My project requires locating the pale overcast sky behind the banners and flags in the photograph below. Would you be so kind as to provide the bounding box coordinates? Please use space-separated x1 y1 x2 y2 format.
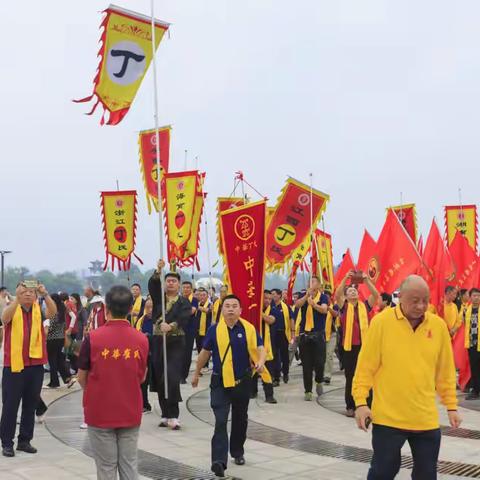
0 0 480 271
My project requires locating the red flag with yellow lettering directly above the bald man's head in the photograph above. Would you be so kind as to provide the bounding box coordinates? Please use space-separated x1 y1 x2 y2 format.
376 210 421 293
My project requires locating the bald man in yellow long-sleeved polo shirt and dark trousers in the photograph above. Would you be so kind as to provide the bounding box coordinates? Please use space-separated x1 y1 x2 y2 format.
352 275 461 480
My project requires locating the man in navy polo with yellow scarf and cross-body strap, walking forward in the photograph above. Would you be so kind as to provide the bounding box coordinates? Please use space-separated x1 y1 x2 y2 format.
192 295 266 477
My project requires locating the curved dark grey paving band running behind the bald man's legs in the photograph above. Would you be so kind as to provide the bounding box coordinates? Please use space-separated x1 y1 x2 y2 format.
187 389 480 478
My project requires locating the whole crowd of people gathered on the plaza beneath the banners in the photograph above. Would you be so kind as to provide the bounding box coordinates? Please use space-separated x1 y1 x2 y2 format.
0 260 480 480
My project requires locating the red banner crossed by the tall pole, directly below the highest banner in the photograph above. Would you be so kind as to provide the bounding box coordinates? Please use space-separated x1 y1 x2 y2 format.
138 126 171 213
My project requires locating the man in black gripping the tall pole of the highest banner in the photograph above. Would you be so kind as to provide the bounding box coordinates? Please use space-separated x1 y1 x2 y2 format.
148 260 192 430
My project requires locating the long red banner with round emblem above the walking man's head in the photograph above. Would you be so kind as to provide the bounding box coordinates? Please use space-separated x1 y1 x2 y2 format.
220 200 267 331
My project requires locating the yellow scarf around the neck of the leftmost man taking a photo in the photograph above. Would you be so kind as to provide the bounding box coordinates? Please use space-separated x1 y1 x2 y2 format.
10 302 43 373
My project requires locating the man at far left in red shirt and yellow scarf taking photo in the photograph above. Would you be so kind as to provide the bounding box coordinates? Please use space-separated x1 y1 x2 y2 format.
0 283 57 457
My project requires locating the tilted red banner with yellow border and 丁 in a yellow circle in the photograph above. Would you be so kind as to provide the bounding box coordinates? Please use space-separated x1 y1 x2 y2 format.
267 178 330 271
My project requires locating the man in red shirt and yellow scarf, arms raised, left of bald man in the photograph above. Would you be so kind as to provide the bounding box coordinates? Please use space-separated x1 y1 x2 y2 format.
335 270 378 418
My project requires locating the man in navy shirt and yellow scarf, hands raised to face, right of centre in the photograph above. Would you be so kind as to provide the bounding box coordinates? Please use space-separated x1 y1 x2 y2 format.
295 276 328 402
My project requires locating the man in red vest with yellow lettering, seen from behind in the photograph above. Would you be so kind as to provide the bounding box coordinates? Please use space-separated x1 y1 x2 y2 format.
78 286 148 480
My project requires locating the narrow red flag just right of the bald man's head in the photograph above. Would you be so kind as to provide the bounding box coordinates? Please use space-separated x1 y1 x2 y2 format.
421 220 454 315
